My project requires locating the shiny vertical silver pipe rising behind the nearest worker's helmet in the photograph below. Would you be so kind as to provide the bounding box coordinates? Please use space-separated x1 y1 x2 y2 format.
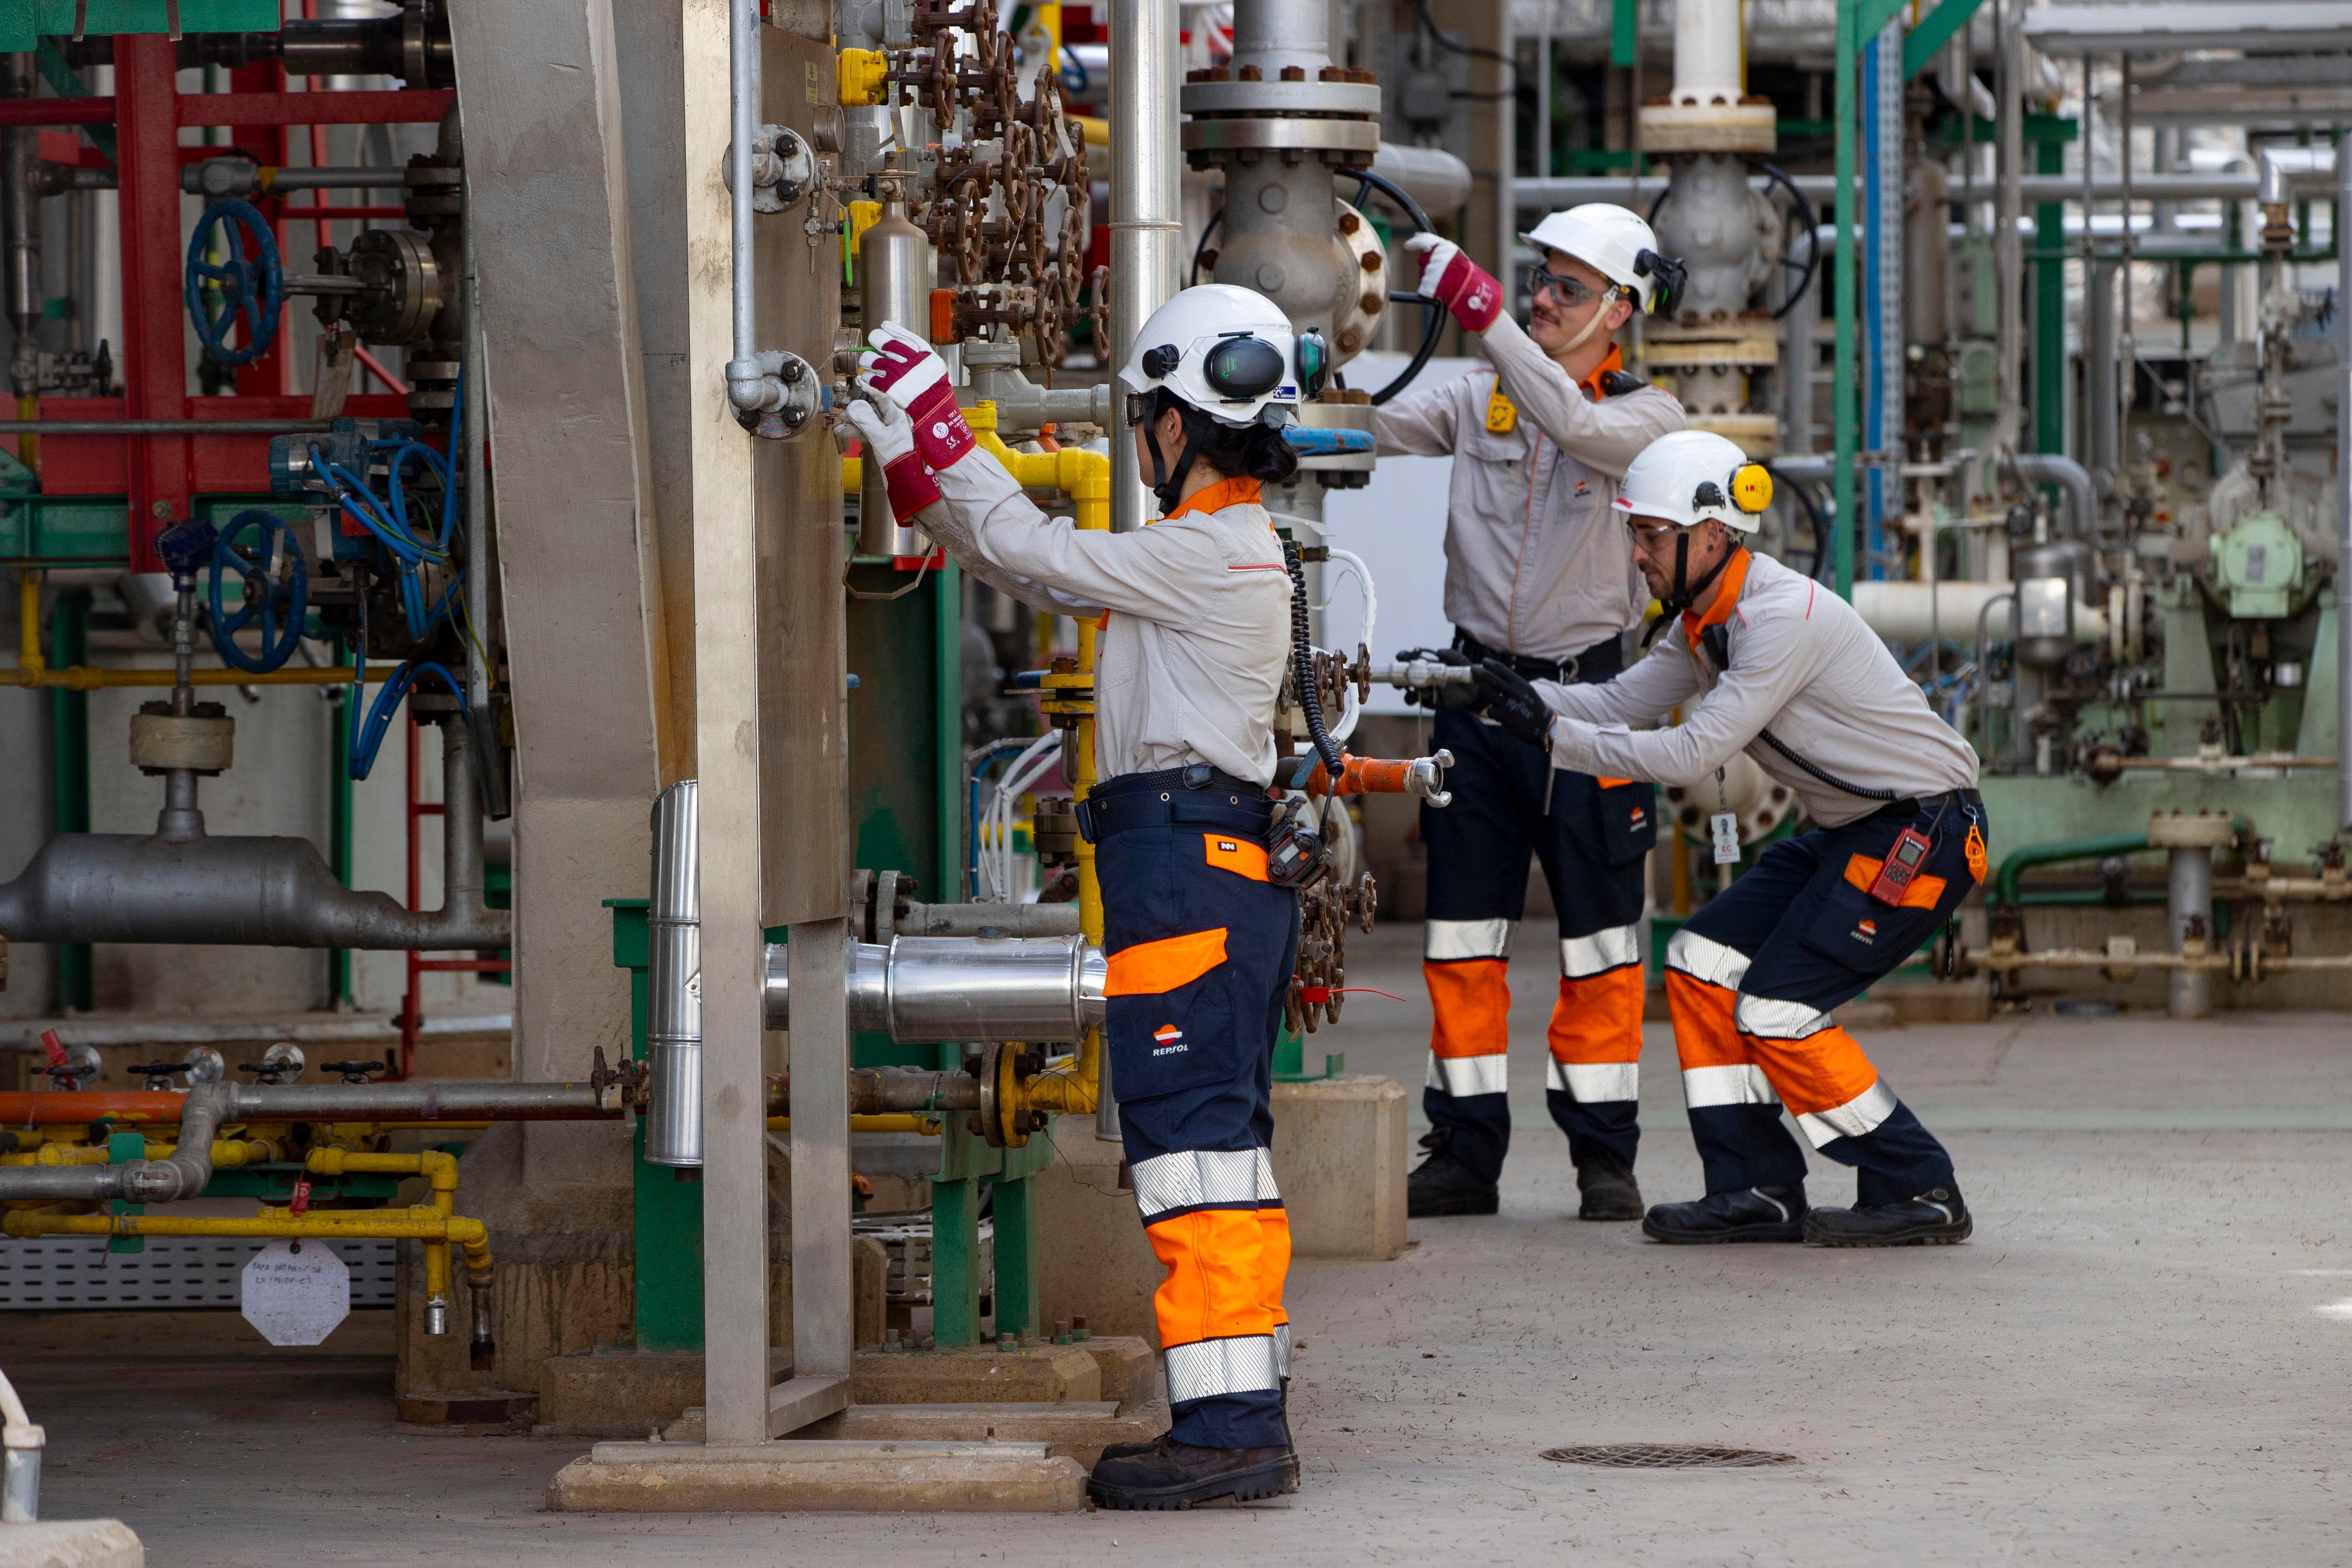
1100 0 1183 534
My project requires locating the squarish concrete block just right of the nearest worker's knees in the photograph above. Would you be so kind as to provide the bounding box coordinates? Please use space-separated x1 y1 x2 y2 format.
1279 1074 1406 1260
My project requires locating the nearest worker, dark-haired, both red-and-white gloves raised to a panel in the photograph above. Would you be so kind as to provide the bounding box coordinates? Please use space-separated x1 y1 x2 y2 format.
847 284 1312 1507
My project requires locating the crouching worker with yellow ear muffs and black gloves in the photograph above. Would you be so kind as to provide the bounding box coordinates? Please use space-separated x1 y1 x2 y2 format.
1479 430 1985 1246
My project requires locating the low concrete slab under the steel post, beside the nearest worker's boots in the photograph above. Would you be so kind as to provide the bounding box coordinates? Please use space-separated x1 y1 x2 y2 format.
548 1438 1087 1514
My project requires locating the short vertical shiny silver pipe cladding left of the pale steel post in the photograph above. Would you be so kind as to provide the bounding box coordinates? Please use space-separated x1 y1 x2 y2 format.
644 778 703 1166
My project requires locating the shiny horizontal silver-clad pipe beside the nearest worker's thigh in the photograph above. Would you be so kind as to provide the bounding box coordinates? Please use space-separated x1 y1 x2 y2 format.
767 936 1110 1044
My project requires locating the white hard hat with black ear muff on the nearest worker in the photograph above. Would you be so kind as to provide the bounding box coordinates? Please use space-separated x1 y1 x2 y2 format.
1120 282 1329 425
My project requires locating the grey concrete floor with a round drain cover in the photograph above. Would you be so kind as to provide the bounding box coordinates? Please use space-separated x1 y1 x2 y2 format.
18 926 2352 1568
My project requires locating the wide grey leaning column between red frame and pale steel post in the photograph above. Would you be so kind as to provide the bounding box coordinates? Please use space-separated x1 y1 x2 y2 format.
451 0 666 1187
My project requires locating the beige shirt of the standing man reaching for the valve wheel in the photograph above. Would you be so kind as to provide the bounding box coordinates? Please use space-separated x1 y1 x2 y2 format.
1378 315 1684 658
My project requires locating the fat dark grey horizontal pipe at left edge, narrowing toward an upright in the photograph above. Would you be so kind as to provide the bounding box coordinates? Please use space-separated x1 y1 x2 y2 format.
0 722 513 952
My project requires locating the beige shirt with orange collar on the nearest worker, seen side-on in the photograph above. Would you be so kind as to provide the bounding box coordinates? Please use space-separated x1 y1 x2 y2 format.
917 449 1291 785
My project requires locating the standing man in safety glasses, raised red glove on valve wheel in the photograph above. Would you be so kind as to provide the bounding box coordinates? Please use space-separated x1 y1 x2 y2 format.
1378 202 1682 1220
